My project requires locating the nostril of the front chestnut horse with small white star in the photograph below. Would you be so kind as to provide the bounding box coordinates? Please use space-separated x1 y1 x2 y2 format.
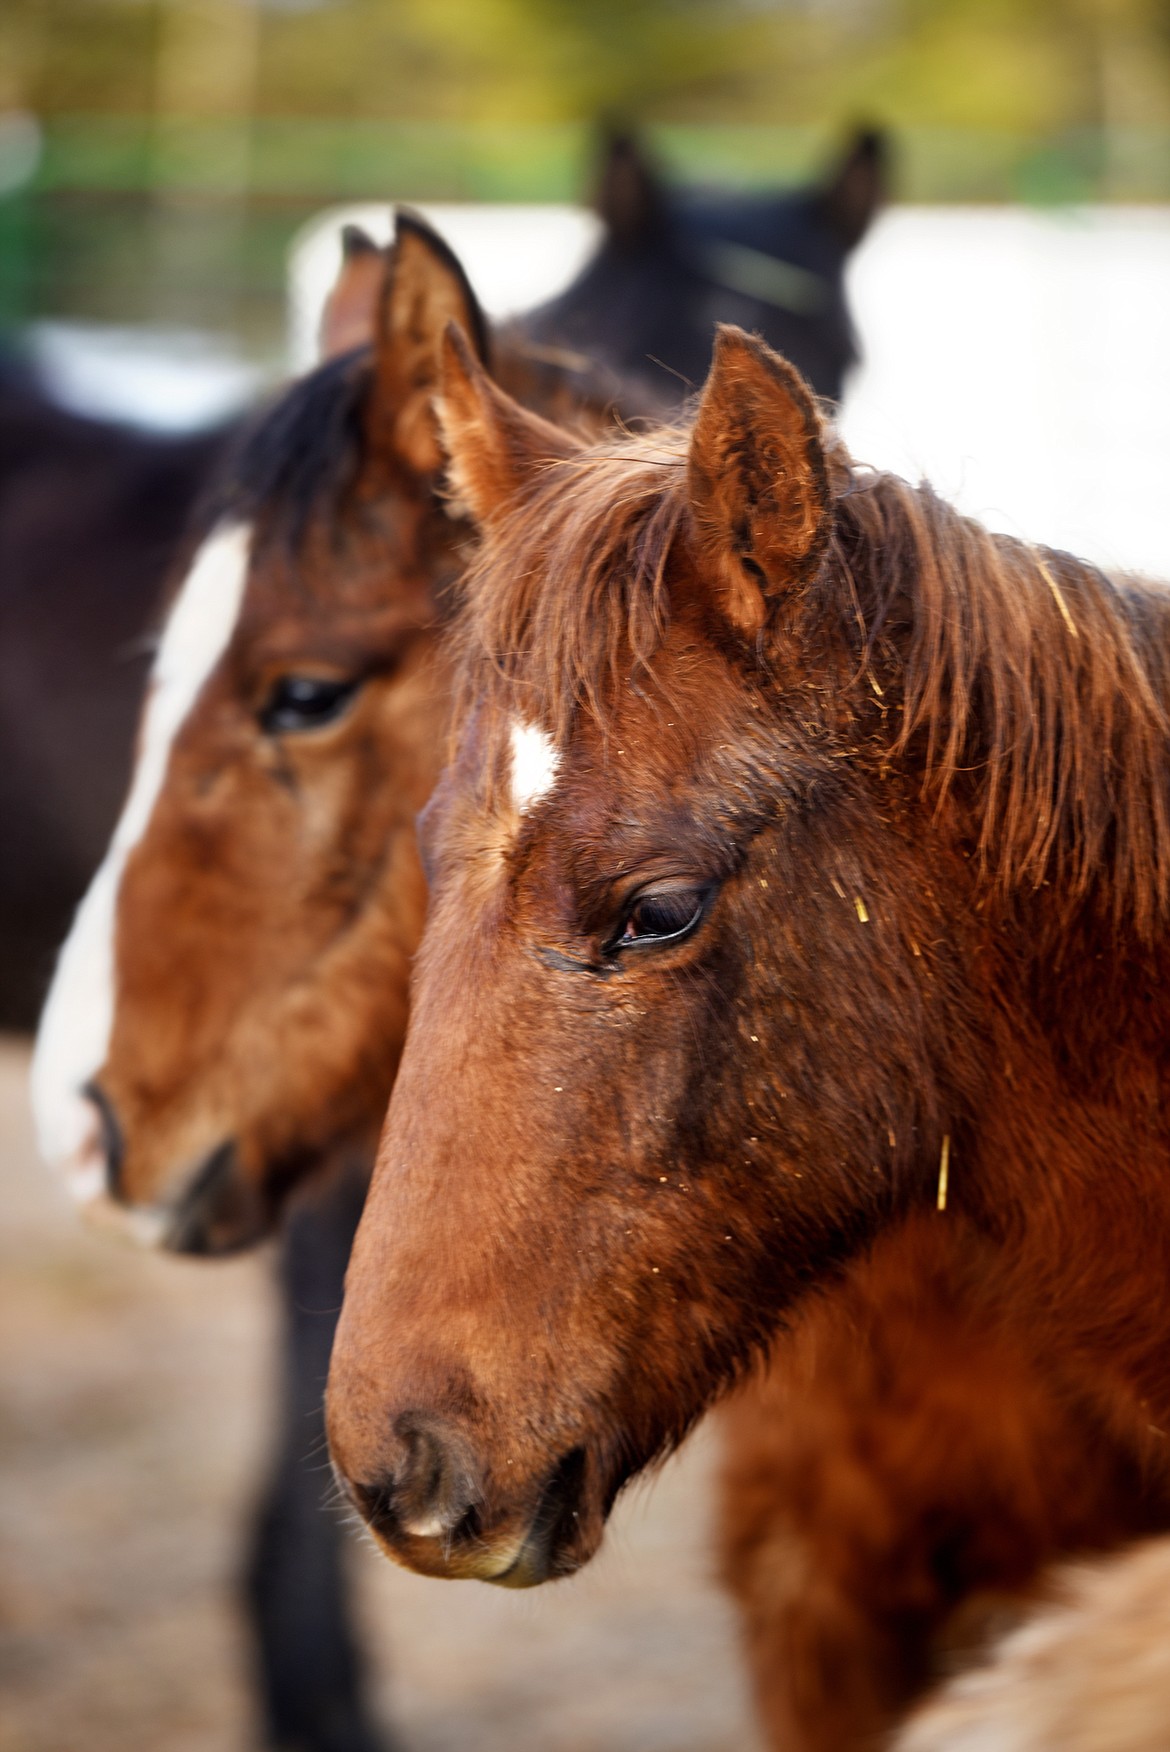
350 1412 482 1538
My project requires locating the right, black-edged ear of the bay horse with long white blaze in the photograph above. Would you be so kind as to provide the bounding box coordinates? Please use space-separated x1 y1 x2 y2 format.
368 207 489 475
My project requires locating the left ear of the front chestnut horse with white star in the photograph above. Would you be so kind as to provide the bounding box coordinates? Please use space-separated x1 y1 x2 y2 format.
436 322 581 524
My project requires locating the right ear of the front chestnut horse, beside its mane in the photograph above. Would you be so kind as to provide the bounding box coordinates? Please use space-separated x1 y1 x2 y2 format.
687 326 832 638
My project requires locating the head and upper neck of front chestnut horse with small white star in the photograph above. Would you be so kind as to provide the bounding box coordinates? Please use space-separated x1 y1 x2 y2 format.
328 329 1170 1586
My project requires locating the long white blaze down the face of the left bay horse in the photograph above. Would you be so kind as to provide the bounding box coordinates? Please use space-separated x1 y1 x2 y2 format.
32 524 250 1204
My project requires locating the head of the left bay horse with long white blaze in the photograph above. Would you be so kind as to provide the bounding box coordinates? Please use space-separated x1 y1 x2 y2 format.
33 215 609 1251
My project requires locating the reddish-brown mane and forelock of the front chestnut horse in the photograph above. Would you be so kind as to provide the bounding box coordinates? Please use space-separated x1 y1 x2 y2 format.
461 411 1170 937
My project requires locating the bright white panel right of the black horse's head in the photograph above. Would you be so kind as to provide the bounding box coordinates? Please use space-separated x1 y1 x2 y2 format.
842 207 1170 578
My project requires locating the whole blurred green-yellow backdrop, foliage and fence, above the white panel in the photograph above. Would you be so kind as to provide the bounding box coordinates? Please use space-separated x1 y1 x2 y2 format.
0 0 1170 334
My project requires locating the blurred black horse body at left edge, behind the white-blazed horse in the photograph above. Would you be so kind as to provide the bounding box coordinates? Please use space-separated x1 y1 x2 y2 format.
0 363 222 1028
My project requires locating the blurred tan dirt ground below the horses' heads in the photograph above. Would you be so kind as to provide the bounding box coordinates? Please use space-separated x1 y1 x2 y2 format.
0 1041 757 1752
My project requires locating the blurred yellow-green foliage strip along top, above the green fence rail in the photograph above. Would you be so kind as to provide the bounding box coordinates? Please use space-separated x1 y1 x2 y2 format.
0 0 1170 133
